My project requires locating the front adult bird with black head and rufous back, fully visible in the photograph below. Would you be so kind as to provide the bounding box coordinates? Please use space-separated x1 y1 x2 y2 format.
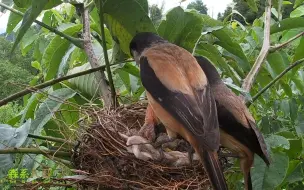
130 32 227 190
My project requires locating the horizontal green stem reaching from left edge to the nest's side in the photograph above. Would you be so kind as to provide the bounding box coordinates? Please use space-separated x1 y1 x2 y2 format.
0 148 71 157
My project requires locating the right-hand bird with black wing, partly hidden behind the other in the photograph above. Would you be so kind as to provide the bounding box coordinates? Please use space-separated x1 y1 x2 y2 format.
195 56 270 190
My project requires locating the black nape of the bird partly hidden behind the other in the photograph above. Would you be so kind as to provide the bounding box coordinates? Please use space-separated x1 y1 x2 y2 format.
194 56 222 85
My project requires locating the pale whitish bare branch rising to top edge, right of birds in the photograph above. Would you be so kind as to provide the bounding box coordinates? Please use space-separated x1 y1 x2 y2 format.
242 0 271 95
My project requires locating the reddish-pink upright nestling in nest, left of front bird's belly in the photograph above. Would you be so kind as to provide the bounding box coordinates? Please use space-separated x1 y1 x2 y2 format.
138 104 157 142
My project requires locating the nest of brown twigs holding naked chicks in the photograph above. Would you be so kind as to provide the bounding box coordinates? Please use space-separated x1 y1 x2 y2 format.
73 103 227 189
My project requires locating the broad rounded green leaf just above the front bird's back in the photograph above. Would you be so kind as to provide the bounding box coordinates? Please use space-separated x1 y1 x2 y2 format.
158 7 203 51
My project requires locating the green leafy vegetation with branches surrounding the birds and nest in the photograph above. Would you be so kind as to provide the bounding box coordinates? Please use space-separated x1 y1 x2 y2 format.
0 0 304 190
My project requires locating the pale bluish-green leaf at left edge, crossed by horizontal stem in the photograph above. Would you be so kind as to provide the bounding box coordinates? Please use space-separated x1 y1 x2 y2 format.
0 119 31 179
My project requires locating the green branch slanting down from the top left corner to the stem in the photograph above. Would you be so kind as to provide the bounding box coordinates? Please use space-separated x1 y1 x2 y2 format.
0 2 83 49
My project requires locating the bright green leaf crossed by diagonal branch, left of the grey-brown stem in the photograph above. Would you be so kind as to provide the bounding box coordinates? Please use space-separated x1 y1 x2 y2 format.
41 24 82 81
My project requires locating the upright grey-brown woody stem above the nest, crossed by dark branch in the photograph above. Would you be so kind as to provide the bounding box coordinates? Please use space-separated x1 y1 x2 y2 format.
80 4 112 107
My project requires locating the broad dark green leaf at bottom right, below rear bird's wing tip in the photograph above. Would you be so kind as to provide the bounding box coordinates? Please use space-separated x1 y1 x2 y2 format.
251 152 289 190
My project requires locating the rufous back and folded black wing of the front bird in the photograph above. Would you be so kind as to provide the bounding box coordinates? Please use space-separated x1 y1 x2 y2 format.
140 55 219 150
